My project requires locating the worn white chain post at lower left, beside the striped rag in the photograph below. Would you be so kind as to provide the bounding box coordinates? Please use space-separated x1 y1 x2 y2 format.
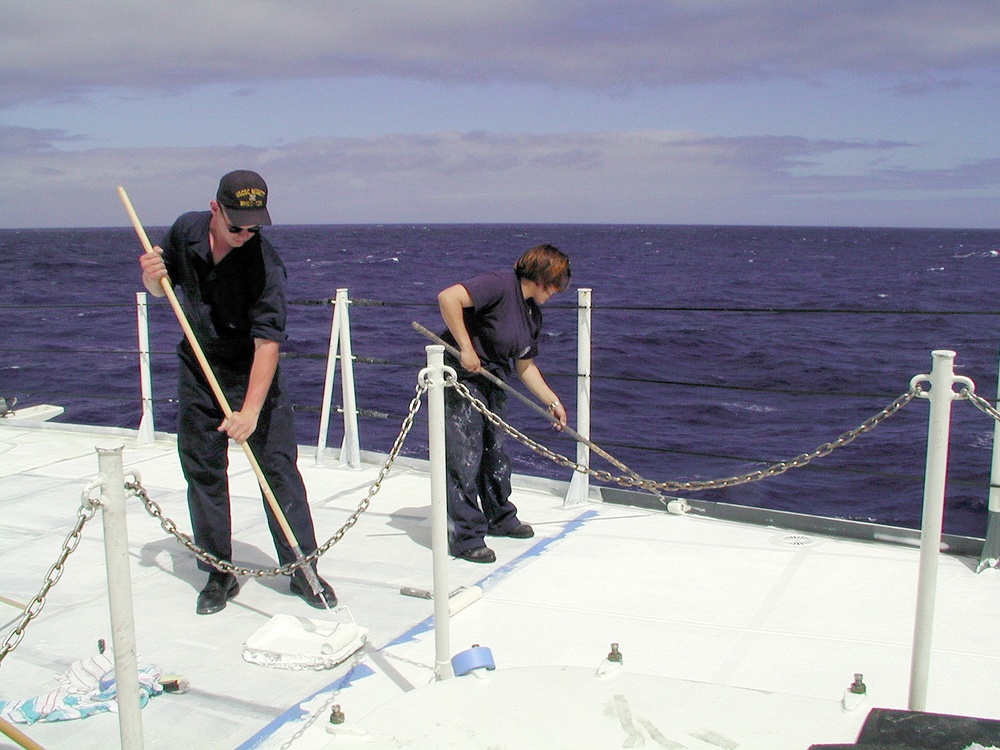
97 448 143 750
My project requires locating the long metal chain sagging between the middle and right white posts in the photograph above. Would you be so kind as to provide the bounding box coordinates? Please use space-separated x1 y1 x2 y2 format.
448 381 920 500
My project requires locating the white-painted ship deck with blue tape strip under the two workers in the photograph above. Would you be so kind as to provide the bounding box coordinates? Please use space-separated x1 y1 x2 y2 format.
0 420 1000 750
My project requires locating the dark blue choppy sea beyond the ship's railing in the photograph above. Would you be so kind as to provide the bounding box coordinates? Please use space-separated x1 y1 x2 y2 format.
0 225 1000 537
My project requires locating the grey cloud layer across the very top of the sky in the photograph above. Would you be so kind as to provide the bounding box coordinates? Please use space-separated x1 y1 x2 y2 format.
0 0 1000 106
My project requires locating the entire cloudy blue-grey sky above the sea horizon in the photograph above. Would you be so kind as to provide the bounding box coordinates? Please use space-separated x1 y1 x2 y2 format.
0 0 1000 228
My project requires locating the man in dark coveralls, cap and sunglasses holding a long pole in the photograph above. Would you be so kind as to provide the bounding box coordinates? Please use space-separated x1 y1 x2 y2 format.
139 170 337 615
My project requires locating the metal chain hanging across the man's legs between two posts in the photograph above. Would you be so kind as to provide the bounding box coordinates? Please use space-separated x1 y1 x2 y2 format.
125 382 427 578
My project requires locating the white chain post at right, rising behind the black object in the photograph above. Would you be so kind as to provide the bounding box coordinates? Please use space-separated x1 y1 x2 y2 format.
908 349 975 711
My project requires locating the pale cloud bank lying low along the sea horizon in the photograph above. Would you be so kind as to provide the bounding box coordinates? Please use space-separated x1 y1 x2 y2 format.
0 130 1000 227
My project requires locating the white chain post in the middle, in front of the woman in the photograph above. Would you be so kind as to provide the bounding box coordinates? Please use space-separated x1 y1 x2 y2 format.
420 344 455 680
